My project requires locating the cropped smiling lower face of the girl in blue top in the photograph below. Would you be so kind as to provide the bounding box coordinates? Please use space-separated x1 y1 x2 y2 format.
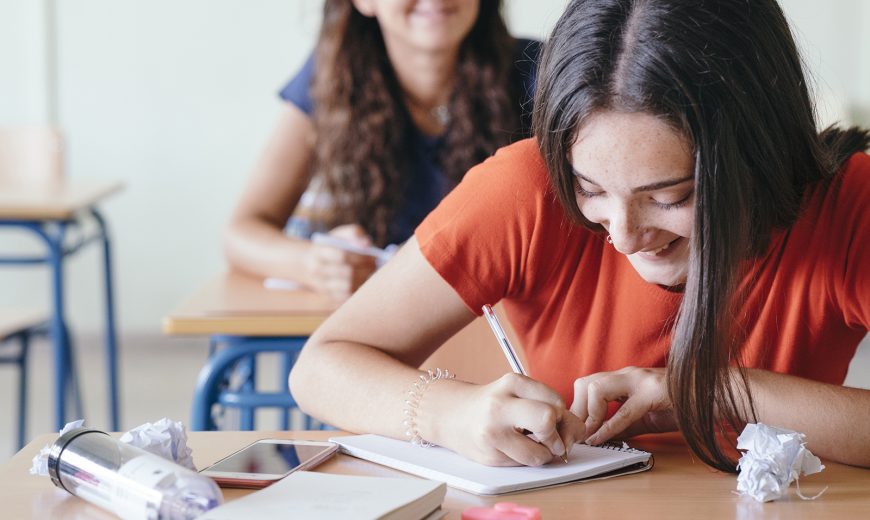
353 0 480 52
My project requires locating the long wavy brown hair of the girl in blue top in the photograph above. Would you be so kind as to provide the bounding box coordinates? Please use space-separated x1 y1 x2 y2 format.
311 0 528 245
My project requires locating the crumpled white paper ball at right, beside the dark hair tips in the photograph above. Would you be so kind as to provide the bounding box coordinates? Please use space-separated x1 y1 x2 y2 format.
737 423 827 502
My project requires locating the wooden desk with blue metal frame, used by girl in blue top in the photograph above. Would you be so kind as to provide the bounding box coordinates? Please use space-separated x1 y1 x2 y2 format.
163 273 338 430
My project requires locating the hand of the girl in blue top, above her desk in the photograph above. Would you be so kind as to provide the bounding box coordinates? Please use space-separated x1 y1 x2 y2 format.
305 224 377 300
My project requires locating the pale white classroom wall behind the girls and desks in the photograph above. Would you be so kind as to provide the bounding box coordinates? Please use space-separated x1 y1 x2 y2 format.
0 0 870 333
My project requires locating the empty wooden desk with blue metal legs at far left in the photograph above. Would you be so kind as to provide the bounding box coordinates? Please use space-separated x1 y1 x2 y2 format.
0 178 123 429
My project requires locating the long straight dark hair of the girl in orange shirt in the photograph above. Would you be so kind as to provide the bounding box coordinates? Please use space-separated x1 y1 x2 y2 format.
533 0 868 471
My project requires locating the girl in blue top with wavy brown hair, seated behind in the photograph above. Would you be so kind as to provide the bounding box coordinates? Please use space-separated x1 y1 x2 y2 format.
225 0 539 299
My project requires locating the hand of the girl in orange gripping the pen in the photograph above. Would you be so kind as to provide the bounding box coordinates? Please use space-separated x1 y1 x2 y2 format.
445 373 585 466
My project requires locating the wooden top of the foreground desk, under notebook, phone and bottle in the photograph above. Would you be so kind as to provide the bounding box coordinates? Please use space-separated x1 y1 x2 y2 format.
0 432 870 520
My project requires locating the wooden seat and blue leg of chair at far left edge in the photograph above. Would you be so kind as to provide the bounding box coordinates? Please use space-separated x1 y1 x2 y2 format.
0 309 48 449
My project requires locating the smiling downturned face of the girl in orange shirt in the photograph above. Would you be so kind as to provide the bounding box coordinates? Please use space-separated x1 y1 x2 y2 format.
570 111 695 286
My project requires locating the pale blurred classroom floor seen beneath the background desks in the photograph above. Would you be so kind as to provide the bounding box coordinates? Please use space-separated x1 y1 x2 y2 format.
0 335 870 462
